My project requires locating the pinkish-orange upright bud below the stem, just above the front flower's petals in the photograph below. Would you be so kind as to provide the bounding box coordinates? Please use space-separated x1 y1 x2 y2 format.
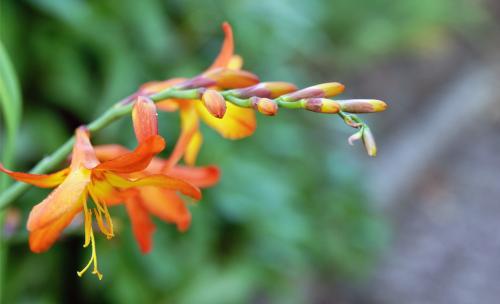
132 96 158 143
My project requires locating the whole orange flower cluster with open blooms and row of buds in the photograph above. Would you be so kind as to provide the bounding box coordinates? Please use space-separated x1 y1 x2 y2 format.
0 23 386 279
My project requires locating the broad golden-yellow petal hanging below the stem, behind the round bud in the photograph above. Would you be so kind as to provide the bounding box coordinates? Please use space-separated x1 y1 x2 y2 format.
196 102 257 139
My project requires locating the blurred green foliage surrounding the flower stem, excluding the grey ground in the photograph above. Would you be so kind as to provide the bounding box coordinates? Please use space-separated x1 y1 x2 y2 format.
0 0 487 303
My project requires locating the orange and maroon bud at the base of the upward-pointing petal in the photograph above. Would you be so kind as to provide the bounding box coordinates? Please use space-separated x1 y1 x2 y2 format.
201 68 259 89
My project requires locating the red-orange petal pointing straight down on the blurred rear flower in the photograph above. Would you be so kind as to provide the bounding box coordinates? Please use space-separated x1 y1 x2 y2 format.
125 198 156 253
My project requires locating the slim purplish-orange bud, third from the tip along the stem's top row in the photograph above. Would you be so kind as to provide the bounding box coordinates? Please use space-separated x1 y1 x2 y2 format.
231 81 297 99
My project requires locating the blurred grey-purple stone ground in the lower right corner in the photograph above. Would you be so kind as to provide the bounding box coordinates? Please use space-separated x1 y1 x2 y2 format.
364 120 500 304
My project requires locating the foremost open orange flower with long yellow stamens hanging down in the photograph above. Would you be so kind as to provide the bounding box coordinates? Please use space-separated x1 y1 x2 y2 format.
0 98 200 279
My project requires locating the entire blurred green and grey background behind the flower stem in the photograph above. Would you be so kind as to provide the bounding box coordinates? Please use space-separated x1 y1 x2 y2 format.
0 0 500 303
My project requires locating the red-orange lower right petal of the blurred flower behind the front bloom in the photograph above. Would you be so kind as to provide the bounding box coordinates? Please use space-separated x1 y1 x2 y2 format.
140 187 191 231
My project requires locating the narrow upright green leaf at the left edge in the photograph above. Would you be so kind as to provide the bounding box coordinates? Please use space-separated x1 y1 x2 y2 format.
0 41 21 189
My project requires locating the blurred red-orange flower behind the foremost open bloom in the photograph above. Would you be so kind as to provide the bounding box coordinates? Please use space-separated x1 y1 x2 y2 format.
95 98 219 253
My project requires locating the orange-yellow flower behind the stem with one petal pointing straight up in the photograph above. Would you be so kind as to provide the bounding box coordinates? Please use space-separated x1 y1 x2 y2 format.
140 23 258 165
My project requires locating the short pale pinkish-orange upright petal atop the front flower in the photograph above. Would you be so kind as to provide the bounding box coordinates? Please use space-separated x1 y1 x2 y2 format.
71 127 99 169
